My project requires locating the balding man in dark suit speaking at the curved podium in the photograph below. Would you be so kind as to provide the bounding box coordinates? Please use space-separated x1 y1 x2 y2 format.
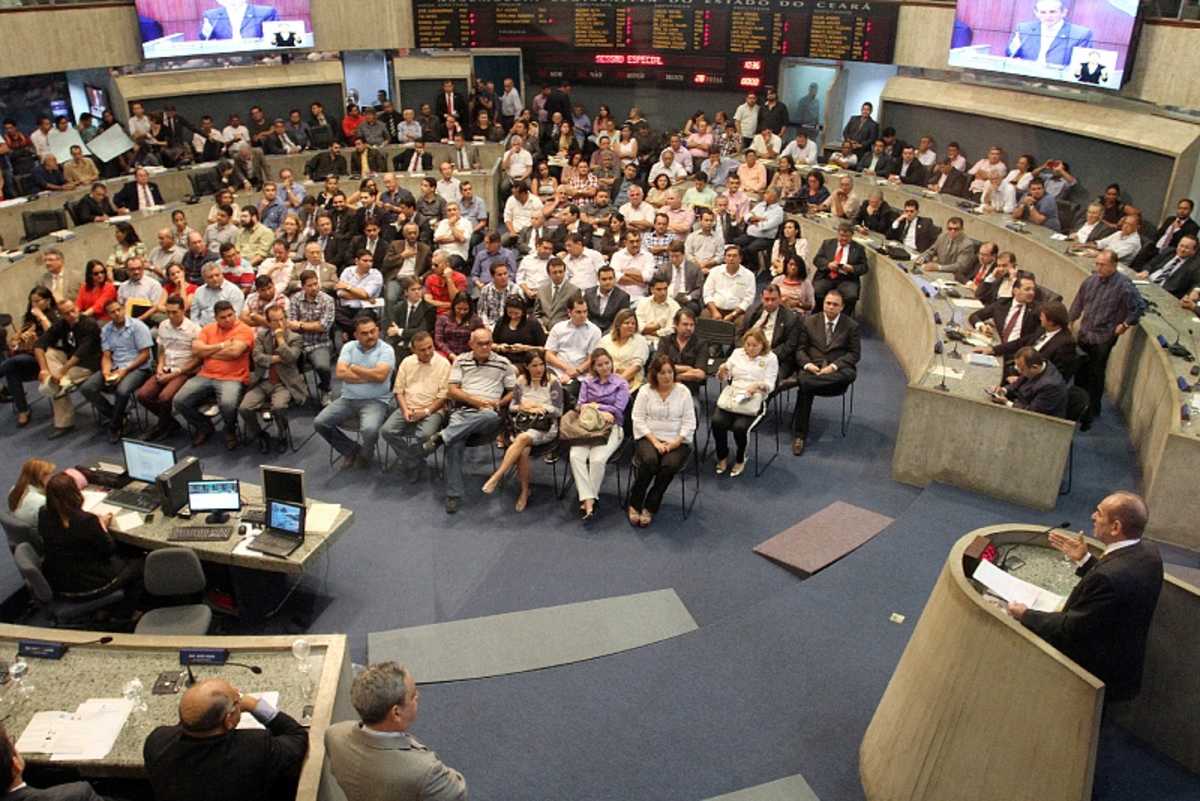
1008 492 1163 701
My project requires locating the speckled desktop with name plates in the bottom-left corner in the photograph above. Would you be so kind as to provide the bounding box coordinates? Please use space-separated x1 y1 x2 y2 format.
0 625 353 801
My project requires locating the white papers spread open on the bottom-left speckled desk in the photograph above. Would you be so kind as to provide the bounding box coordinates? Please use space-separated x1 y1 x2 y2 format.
17 698 133 761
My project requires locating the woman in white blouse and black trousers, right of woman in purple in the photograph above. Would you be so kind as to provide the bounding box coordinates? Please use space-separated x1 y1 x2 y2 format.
629 354 696 529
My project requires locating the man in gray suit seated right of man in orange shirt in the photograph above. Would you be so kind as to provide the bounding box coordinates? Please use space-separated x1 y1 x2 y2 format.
238 303 308 453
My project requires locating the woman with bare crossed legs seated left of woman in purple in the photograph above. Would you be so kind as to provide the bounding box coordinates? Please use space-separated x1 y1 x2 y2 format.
484 350 563 512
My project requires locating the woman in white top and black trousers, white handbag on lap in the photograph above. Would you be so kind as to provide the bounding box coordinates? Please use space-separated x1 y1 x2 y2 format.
713 329 779 478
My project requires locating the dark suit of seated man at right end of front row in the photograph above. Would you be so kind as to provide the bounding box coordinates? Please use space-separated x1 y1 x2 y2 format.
791 309 863 439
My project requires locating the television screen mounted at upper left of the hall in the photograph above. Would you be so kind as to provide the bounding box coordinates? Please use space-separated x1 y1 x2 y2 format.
137 0 312 59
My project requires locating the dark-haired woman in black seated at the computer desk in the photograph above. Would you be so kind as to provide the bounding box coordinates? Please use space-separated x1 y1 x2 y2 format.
37 472 142 597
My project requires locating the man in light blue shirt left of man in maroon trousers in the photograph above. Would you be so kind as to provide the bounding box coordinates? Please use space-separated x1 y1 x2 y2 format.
79 299 154 442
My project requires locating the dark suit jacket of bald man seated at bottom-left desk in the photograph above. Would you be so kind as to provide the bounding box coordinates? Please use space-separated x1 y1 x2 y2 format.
142 712 308 801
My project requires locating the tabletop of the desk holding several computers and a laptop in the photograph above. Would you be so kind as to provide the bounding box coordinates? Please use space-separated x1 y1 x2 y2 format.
104 476 354 573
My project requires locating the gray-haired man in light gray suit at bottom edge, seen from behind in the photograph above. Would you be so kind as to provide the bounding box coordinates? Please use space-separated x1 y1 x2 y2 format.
325 662 467 801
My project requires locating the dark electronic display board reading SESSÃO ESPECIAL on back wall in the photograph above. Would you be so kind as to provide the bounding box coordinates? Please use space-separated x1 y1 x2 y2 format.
413 0 900 89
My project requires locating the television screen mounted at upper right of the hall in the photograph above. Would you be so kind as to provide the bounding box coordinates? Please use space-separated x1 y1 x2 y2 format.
949 0 1138 90
